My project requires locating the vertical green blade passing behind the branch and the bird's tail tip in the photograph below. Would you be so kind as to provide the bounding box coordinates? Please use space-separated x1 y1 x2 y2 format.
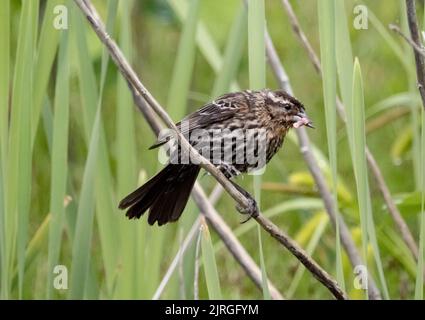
114 1 142 299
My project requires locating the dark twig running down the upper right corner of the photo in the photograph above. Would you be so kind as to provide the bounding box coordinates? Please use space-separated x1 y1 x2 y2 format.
406 0 425 109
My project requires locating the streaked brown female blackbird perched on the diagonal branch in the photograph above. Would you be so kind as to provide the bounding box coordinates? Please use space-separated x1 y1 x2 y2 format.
119 89 312 225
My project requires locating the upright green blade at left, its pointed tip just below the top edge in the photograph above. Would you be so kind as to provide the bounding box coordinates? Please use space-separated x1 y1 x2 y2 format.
47 31 69 299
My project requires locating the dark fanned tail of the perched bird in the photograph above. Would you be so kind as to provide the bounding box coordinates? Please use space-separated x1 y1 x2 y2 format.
119 164 200 225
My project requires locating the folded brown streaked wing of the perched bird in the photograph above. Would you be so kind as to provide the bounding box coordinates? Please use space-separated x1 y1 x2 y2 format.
149 93 246 149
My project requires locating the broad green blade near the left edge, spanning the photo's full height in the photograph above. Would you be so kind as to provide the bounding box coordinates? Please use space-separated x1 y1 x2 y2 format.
5 1 38 297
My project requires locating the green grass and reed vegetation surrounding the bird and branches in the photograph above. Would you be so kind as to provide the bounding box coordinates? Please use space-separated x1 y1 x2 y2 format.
0 0 425 299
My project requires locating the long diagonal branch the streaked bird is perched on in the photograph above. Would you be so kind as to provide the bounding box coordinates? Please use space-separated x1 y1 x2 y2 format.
74 0 347 299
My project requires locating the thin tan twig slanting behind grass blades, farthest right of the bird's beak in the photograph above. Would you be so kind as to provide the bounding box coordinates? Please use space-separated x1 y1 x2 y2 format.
282 0 418 268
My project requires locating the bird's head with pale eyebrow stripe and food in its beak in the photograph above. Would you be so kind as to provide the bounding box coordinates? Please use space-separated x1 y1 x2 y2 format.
265 90 314 128
